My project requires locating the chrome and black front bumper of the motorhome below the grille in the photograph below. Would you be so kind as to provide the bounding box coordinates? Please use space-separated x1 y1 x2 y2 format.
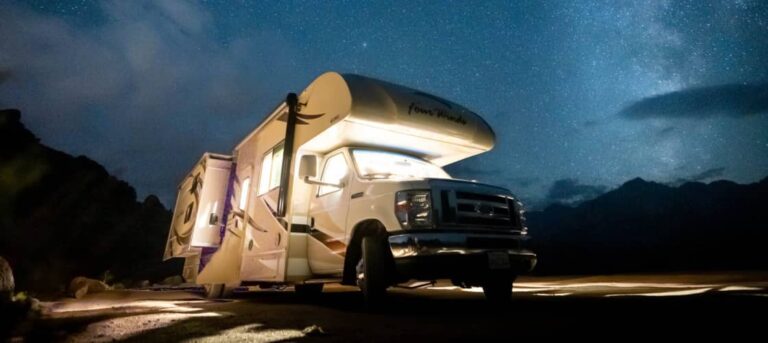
389 230 537 280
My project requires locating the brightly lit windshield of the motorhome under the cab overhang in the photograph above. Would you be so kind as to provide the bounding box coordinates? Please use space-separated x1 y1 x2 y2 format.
352 149 451 179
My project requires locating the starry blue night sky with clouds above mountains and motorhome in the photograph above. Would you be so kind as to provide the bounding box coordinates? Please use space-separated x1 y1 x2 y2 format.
0 0 768 205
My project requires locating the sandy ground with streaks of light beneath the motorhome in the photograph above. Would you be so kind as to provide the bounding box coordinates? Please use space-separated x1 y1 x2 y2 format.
20 272 768 342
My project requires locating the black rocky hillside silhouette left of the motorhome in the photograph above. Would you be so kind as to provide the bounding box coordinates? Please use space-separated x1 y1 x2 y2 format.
0 109 181 292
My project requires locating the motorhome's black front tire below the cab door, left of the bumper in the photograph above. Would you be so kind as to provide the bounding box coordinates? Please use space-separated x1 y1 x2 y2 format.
356 236 390 307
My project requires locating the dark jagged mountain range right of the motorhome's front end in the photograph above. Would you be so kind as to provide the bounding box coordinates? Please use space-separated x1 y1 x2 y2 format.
527 178 768 274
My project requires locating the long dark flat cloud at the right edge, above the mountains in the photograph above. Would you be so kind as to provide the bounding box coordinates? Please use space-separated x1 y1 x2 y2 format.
620 84 768 119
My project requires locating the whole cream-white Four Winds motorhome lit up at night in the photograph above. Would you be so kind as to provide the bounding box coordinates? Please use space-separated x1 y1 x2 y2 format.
165 72 536 303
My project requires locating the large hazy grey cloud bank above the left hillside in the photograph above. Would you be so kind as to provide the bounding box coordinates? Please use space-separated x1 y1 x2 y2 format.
0 1 305 205
